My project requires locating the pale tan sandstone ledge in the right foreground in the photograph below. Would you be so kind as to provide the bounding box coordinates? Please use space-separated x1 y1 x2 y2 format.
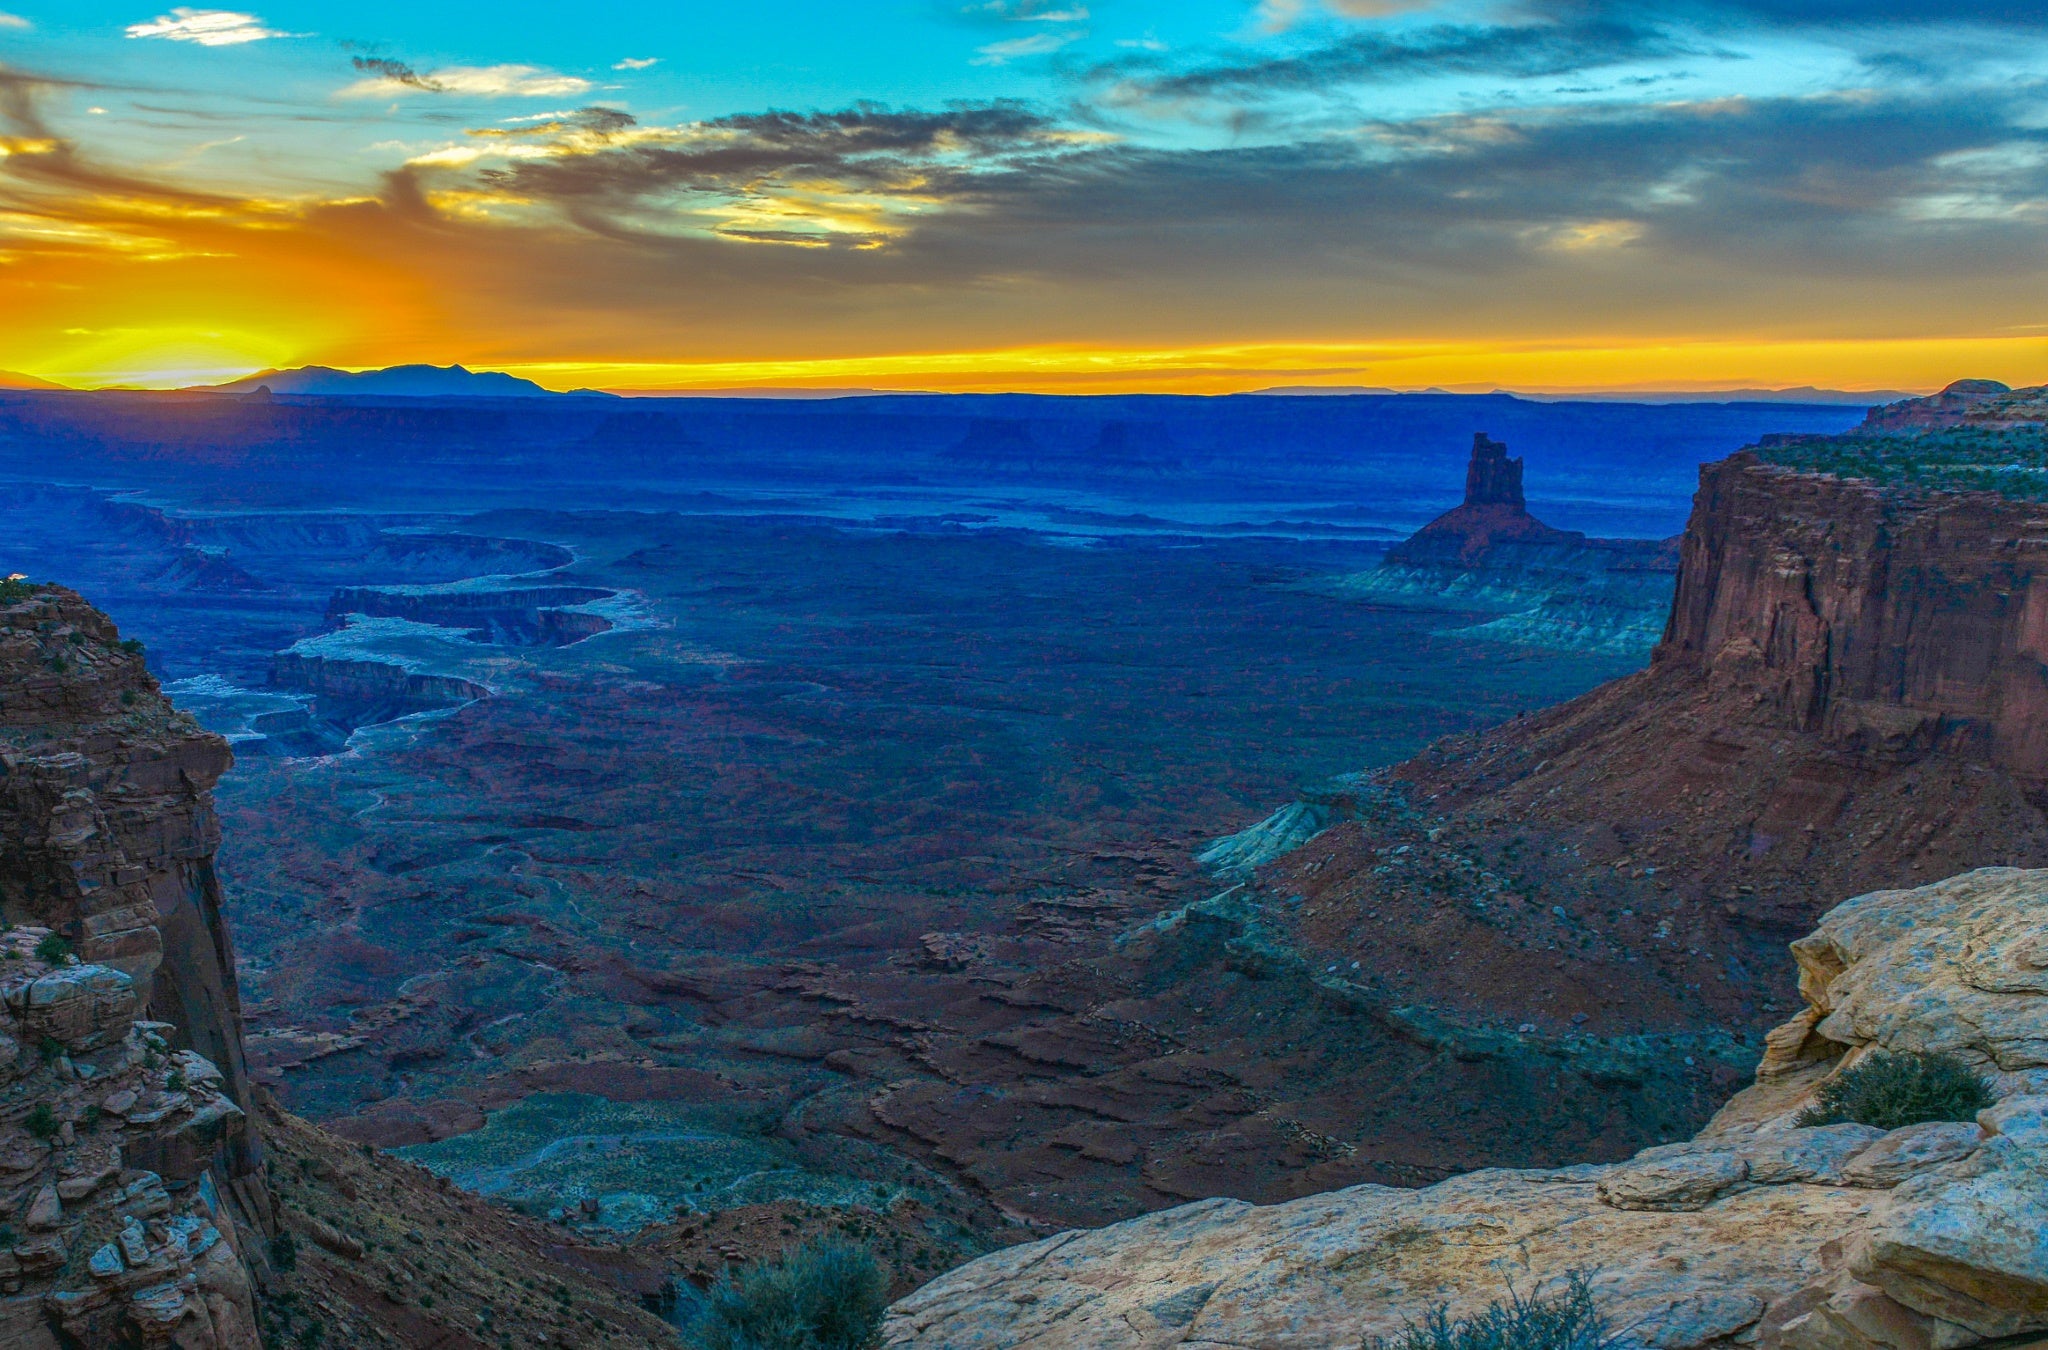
885 869 2048 1350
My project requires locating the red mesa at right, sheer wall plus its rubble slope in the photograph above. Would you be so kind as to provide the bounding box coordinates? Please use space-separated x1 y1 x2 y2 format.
1268 455 2048 1057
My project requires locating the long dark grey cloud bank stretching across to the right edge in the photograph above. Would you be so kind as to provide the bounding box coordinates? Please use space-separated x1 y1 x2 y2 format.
420 78 2048 307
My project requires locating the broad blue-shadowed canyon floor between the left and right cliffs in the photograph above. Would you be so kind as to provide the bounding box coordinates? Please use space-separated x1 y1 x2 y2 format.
6 391 1875 1289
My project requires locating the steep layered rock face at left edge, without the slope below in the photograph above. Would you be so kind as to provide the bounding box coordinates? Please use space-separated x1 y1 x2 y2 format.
0 586 272 1350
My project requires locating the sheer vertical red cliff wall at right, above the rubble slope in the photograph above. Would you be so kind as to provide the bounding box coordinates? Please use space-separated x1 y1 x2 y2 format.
1657 455 2048 783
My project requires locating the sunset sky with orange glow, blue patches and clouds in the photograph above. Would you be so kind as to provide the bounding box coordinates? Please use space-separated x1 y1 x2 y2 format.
0 0 2048 393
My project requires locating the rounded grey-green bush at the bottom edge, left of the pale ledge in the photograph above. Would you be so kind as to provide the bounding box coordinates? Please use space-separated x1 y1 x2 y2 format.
688 1239 889 1350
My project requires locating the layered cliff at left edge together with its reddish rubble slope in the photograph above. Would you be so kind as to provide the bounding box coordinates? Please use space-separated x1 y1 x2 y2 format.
0 582 688 1350
